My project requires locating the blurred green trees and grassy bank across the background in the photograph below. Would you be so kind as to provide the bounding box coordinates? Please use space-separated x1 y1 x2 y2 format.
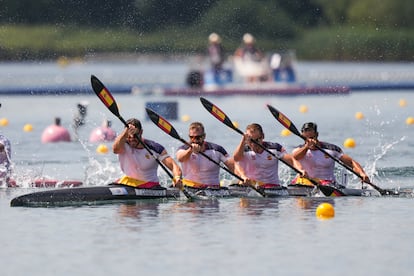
0 0 414 60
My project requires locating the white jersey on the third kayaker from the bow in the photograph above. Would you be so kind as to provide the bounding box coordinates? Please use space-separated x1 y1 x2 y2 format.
238 142 286 185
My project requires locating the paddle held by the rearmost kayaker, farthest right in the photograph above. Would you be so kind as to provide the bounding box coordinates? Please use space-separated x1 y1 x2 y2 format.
267 105 395 195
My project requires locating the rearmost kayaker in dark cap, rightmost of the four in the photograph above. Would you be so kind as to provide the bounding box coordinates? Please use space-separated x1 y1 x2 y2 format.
292 122 371 188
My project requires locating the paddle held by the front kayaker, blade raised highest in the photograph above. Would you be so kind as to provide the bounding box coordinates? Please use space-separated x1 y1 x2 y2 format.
91 75 192 199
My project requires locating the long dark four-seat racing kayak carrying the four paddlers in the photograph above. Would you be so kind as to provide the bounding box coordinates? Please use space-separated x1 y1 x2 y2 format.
10 183 388 207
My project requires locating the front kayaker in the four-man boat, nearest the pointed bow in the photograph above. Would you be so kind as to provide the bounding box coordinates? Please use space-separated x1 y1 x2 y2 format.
112 118 182 188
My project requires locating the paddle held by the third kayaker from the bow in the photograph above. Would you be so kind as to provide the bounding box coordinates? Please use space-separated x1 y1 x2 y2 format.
200 97 345 196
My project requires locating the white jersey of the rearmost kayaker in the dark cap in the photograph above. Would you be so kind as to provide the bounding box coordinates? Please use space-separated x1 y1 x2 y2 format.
298 142 343 182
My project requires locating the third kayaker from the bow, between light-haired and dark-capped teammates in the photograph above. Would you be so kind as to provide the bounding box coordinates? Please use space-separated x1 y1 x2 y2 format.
233 123 306 189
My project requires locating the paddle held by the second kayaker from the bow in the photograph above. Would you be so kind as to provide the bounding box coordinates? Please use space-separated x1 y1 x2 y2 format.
146 107 265 196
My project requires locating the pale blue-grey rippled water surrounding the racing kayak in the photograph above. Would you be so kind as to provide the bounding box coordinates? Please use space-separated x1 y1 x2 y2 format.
0 63 414 275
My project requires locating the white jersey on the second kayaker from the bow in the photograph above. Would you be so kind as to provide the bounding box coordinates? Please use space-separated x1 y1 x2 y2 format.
177 142 230 185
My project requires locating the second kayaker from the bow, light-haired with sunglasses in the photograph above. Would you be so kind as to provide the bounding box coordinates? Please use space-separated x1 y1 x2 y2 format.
176 122 234 188
